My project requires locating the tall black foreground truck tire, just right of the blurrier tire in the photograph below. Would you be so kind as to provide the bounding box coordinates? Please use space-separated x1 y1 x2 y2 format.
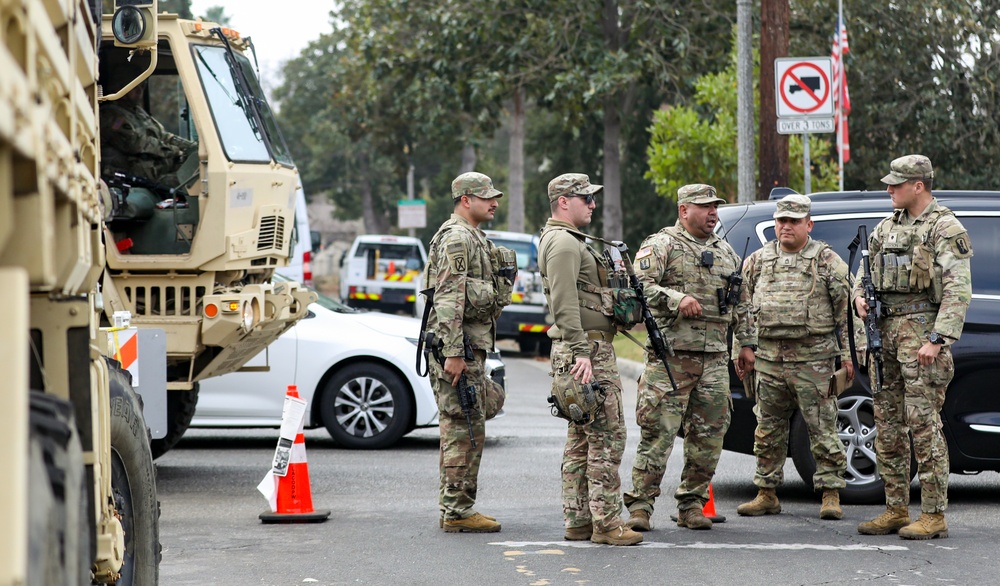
109 367 160 586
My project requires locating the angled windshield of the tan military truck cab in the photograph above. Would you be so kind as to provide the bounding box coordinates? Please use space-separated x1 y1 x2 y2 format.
192 45 292 165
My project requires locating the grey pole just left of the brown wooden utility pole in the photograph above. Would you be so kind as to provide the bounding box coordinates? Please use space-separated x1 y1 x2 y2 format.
736 0 757 203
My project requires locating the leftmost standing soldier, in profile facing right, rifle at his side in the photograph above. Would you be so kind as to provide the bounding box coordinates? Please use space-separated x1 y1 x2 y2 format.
424 173 511 533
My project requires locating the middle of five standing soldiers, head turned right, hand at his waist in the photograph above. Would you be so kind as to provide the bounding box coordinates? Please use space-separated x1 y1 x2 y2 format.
625 184 740 531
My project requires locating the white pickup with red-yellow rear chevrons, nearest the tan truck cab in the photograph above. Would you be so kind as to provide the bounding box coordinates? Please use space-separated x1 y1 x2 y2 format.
340 234 427 315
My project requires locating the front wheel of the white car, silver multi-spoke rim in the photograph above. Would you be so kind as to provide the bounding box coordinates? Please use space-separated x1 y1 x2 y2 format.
320 364 413 450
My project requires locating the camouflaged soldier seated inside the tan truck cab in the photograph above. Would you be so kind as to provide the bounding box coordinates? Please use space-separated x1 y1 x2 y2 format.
101 83 198 187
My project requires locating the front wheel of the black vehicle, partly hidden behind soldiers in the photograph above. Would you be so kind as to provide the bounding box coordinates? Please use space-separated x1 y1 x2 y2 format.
790 388 896 504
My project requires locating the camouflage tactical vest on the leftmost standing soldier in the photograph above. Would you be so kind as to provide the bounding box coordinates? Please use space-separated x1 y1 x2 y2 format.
424 221 512 323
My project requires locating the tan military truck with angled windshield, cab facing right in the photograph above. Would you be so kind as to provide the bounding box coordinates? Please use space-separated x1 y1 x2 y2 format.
99 6 312 457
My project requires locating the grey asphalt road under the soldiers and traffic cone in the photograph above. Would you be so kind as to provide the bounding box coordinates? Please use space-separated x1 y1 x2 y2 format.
157 355 1000 586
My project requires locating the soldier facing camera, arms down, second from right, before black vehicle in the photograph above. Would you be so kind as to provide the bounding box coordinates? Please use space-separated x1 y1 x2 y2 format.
736 194 854 519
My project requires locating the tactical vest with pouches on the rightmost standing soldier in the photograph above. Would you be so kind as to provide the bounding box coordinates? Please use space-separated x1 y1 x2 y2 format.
872 206 955 303
